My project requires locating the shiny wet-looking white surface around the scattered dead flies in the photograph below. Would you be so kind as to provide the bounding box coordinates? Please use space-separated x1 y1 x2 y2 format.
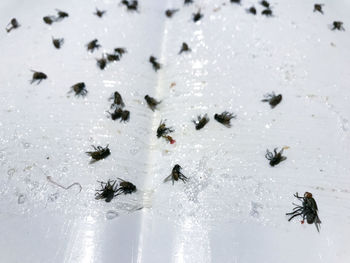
0 0 350 263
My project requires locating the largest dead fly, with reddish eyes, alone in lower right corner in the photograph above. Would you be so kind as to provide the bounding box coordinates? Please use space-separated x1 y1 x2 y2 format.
286 192 321 232
